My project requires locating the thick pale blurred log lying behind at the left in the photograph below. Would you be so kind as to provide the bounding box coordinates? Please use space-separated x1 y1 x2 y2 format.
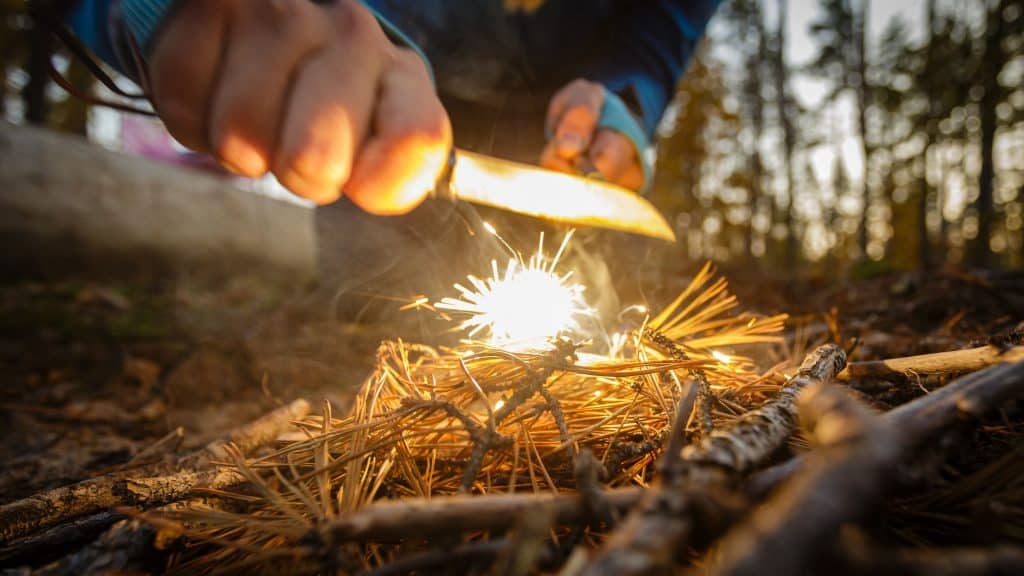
0 122 316 286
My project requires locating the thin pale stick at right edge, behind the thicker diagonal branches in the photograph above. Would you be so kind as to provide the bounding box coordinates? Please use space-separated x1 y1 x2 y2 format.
839 345 1024 380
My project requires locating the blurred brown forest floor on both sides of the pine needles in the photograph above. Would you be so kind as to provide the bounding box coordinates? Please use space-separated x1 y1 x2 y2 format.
0 264 1024 568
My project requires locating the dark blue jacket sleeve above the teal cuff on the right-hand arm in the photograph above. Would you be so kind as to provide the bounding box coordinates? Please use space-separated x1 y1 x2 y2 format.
587 0 721 136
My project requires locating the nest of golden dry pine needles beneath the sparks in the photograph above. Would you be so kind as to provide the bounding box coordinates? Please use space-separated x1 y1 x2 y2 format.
134 266 784 573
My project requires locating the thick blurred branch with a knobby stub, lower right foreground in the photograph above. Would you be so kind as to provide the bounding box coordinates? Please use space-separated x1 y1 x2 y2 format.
716 362 1024 575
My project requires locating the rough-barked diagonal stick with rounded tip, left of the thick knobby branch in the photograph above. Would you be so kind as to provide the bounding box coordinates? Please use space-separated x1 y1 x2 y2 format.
583 344 846 576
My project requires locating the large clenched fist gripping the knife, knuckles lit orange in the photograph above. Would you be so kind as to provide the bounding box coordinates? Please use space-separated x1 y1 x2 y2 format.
147 0 452 214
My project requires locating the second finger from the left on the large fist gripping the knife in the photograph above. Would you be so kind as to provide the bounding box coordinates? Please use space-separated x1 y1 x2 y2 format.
208 0 328 177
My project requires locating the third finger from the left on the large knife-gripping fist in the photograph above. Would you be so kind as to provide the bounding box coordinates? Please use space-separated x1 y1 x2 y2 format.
273 42 380 204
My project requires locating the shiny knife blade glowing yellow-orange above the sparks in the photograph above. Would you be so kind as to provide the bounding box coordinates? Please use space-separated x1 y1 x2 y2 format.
433 150 676 242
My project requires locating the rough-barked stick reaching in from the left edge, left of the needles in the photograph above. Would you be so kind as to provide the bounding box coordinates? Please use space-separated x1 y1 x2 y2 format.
0 399 309 543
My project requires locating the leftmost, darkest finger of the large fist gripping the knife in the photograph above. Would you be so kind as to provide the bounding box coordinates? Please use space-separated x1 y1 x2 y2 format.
147 0 227 152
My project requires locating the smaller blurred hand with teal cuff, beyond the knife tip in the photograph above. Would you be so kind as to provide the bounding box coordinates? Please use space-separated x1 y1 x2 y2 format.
541 79 644 190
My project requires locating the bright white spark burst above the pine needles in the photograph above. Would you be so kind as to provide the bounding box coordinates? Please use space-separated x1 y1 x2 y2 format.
435 223 593 349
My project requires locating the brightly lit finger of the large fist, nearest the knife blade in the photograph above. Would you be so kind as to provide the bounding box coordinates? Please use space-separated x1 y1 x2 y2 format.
345 50 452 214
